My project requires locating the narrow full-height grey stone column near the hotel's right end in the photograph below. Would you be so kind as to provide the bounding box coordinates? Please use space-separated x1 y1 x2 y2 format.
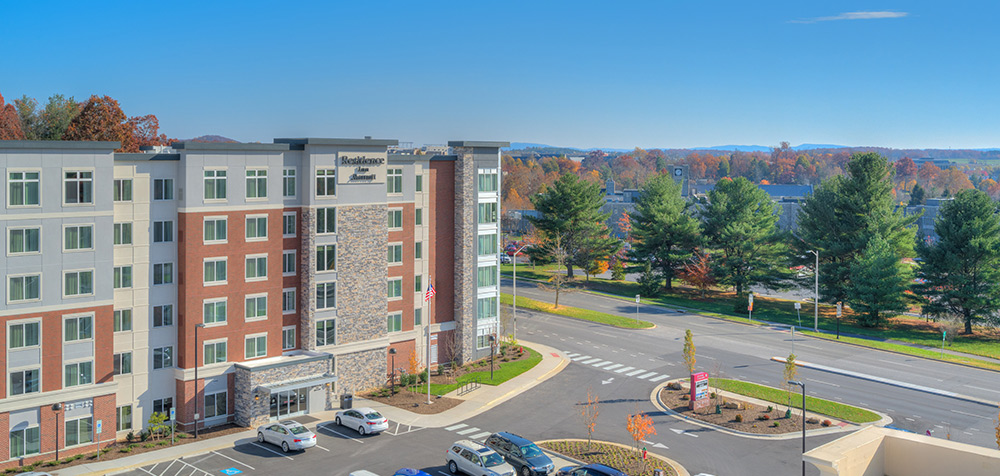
454 147 476 364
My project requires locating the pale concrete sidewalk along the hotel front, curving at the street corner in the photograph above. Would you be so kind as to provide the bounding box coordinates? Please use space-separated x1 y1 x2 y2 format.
56 341 569 476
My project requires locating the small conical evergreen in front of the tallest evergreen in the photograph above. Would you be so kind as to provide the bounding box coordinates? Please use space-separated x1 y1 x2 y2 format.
846 235 913 327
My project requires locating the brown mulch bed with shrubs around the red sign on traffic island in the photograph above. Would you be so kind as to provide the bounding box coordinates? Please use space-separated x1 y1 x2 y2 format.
660 387 823 435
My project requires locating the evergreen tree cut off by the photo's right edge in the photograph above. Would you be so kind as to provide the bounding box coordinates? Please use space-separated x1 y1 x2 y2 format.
917 190 1000 334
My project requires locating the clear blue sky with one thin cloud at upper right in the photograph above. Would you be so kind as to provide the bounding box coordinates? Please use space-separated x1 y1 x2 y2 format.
0 0 1000 148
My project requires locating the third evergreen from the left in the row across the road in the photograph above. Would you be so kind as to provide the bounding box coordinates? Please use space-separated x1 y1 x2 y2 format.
703 177 790 296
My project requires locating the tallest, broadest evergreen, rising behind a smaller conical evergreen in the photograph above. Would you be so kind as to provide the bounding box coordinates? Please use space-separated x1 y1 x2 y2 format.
796 152 919 301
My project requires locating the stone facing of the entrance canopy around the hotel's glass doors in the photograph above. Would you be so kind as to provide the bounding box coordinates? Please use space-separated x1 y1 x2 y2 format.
233 359 332 427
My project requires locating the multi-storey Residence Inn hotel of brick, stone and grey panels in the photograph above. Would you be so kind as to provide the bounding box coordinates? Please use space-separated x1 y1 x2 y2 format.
0 138 507 469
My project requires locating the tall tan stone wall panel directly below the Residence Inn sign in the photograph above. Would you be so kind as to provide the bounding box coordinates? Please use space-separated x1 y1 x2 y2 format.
337 204 386 346
